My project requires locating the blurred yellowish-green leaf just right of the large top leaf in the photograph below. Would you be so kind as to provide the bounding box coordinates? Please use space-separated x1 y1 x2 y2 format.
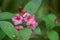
35 4 48 21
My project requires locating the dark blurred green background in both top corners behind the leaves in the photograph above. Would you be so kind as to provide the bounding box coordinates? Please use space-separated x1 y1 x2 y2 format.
0 0 60 13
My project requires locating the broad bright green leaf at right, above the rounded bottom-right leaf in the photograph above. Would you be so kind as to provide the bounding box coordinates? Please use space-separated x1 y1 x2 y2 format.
43 14 57 28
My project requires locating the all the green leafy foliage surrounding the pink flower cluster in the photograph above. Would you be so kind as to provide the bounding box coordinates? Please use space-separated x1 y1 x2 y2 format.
0 0 60 40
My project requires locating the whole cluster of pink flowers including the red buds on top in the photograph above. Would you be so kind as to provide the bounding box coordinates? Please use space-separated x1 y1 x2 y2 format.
12 8 38 30
